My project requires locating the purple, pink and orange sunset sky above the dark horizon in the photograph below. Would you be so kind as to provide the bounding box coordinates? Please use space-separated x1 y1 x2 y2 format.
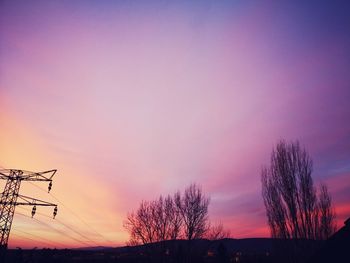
0 0 350 251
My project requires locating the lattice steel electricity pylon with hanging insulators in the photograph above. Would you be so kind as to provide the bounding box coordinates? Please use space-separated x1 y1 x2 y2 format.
0 169 57 250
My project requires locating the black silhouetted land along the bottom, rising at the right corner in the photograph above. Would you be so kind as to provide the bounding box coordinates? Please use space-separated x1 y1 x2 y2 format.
1 219 350 263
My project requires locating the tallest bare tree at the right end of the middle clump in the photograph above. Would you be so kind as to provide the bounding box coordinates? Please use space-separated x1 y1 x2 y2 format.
177 184 209 240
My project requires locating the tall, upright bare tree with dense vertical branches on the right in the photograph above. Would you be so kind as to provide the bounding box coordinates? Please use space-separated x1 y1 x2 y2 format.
261 141 335 261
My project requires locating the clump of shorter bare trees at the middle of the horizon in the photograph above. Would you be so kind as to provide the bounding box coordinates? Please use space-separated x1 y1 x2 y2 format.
124 184 209 245
